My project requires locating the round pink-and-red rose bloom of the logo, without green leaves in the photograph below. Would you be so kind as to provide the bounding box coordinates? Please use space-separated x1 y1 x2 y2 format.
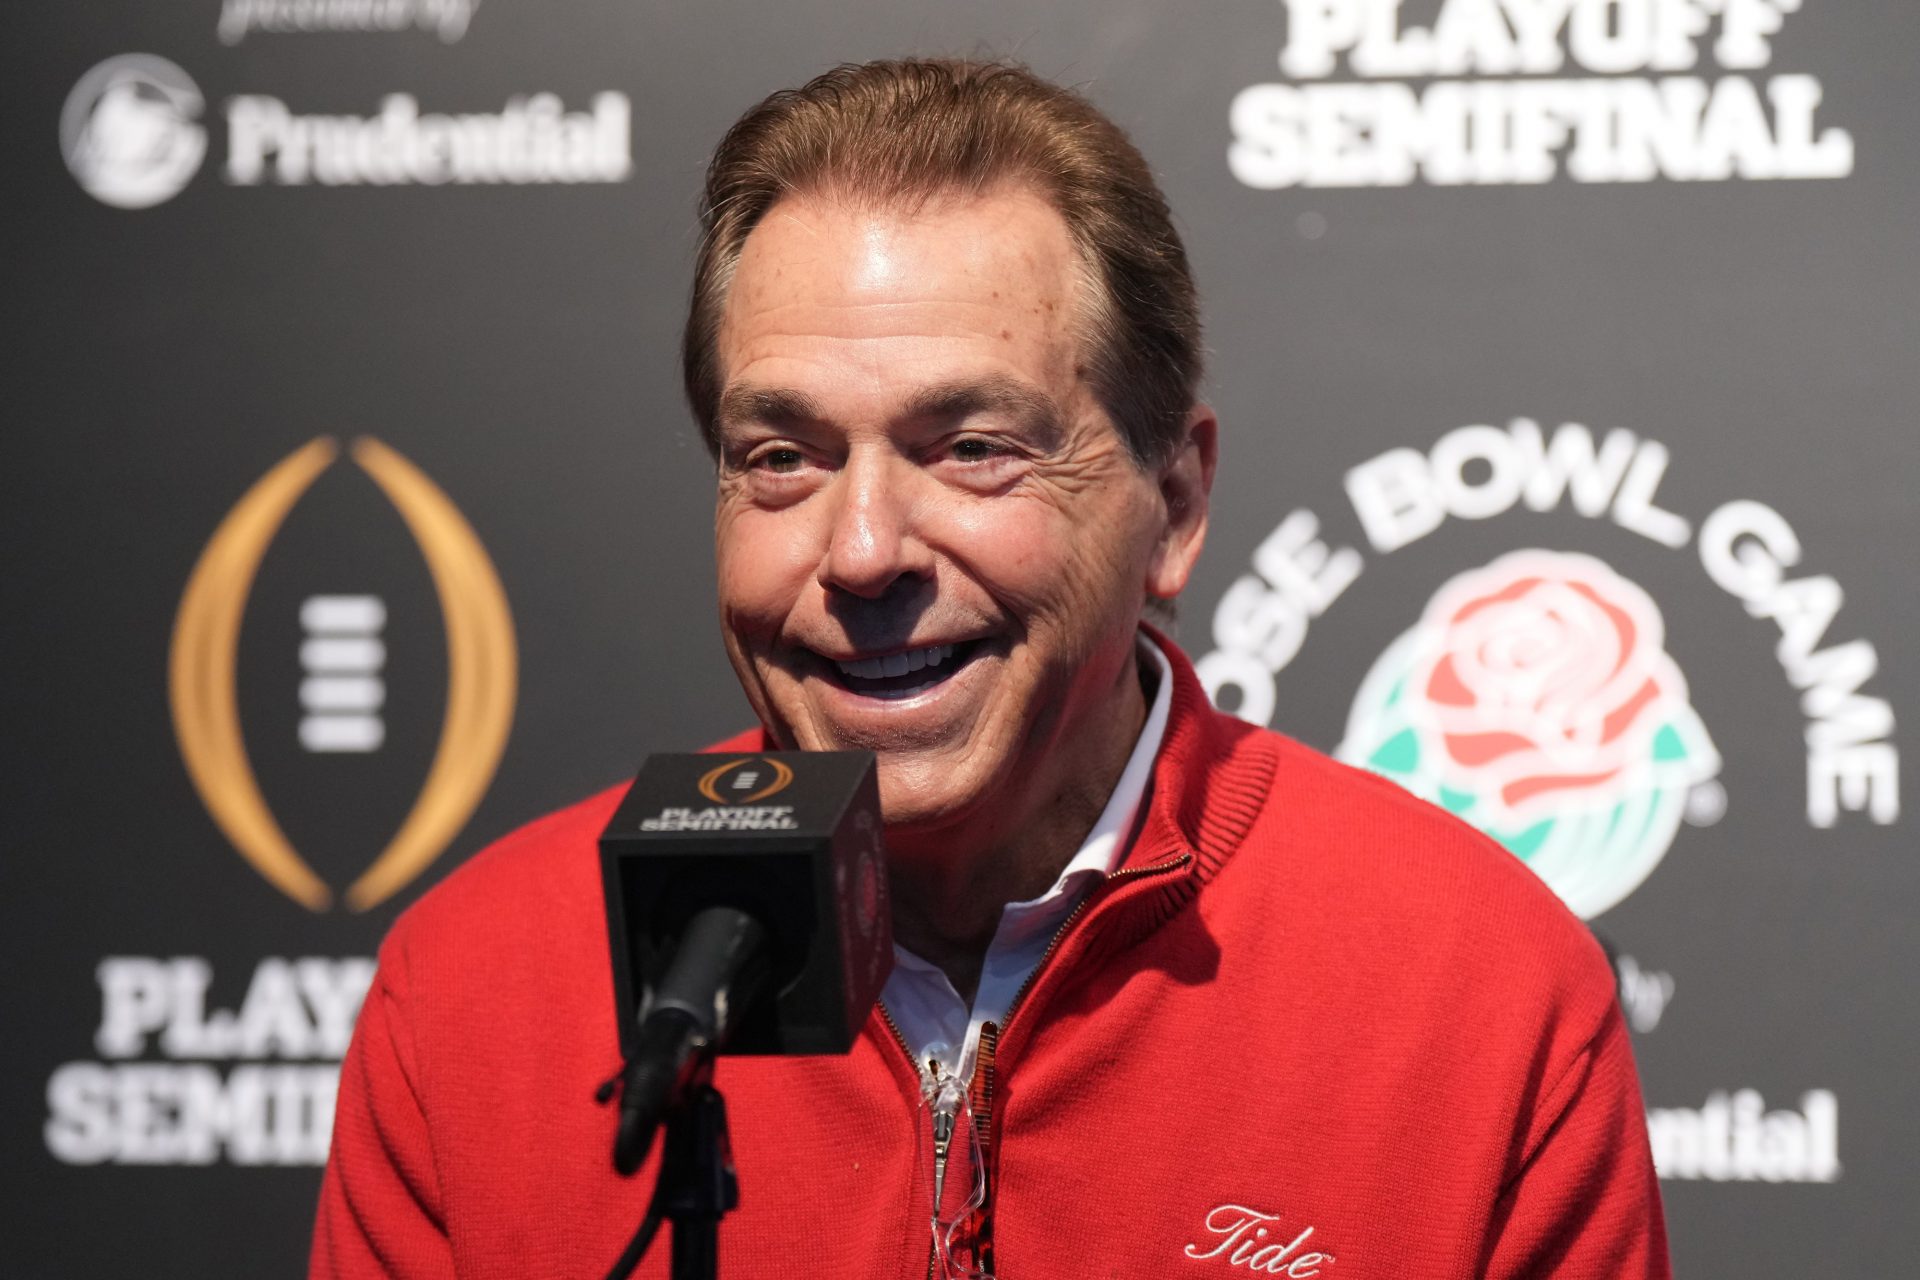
1411 551 1688 823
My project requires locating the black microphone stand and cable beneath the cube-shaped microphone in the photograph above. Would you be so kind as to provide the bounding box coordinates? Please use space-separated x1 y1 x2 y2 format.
607 1057 739 1280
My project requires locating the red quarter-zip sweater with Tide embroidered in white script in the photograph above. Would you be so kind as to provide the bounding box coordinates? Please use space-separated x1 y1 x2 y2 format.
311 645 1668 1280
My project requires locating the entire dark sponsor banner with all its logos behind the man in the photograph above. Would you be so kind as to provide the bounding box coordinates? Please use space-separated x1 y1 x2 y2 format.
0 0 1920 1276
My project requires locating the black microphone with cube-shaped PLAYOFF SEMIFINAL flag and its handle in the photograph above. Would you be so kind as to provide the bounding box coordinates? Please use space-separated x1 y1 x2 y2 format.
599 752 893 1174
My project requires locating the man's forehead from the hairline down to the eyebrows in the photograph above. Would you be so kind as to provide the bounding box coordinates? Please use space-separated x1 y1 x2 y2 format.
714 186 1083 432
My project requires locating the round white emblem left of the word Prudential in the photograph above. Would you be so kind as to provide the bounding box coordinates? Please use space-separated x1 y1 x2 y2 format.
60 54 207 209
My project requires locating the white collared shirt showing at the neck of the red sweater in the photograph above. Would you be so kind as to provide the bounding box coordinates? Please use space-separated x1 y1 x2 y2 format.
879 633 1173 1080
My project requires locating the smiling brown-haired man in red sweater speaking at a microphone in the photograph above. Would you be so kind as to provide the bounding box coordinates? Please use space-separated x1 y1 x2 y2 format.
313 61 1667 1280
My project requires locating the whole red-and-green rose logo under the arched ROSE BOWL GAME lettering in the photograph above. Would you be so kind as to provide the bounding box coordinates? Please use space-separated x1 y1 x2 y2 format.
1338 551 1720 917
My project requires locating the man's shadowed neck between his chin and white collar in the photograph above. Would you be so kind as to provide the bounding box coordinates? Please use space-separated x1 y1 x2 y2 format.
891 652 1146 1004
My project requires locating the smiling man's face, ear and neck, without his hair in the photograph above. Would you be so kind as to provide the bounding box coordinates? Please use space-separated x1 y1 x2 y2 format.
714 180 1213 998
